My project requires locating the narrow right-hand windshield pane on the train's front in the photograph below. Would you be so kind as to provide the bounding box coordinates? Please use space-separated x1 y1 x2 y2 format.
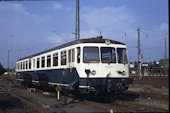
117 48 128 64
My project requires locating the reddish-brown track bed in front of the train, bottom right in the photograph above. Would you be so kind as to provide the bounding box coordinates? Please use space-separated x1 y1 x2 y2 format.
81 93 168 112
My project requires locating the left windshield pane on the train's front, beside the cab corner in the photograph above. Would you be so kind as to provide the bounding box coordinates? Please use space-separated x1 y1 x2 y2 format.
83 47 99 63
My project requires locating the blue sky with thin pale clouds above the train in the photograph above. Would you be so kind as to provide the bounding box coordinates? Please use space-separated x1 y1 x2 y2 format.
0 0 169 68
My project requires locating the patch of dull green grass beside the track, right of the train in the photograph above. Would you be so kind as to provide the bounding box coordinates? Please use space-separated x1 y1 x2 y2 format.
129 84 169 94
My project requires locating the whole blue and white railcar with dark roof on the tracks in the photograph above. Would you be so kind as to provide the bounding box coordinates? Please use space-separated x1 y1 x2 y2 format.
16 36 133 93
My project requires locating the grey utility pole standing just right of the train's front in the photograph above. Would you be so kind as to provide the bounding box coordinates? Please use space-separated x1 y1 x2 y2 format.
137 27 142 79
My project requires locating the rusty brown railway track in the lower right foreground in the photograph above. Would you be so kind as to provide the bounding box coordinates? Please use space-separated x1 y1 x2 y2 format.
84 100 168 113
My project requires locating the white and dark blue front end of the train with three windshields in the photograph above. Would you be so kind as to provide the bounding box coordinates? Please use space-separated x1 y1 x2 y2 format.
78 40 133 94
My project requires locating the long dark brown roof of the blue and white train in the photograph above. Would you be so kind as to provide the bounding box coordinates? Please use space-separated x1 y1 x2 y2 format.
18 36 125 61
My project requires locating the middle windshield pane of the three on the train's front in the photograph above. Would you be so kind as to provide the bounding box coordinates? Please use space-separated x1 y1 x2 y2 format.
101 47 116 63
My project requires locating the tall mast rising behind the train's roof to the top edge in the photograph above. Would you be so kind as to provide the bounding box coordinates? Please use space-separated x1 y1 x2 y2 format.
75 0 80 40
